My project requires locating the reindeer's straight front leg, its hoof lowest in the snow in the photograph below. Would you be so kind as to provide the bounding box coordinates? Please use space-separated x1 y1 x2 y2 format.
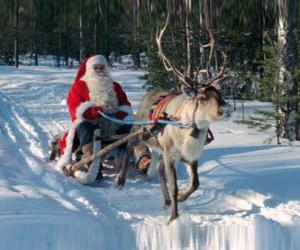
163 151 178 222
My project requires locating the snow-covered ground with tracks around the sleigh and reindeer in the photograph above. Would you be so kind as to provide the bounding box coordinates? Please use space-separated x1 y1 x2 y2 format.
0 66 300 250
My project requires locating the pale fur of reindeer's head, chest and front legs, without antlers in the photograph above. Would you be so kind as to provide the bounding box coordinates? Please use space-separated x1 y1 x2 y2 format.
133 87 229 221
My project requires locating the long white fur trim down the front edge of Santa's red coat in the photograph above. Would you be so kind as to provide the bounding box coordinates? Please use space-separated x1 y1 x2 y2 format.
55 101 95 172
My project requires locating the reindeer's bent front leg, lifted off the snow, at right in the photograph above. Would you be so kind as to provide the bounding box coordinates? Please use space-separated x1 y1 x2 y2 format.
178 161 199 202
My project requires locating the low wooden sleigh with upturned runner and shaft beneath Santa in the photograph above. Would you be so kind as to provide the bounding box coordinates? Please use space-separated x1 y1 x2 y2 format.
49 129 149 187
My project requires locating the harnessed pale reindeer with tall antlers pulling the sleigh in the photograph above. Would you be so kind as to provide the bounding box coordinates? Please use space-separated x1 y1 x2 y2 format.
124 9 230 222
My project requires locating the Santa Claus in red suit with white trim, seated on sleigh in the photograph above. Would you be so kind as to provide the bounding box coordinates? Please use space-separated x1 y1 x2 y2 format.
56 55 133 174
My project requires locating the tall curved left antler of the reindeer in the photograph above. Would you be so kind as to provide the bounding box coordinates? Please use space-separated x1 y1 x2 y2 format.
156 13 192 87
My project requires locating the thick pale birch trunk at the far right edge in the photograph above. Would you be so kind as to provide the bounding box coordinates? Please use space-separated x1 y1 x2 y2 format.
276 0 297 140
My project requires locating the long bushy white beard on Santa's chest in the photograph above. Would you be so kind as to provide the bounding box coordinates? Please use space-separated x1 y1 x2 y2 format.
82 74 118 113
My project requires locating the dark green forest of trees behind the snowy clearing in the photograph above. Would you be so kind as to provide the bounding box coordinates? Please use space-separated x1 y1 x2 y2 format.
0 0 300 144
